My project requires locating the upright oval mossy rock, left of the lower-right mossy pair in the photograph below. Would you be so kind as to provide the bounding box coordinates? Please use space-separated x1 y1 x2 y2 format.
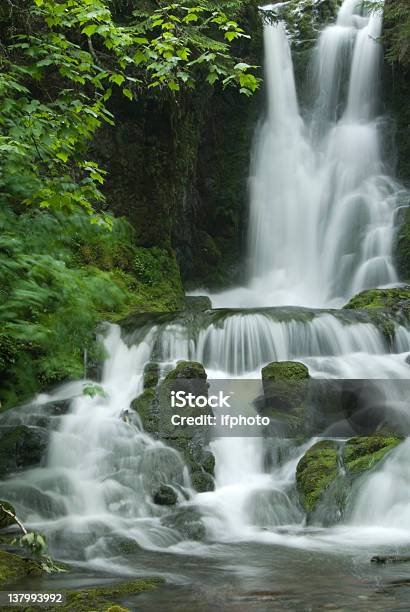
296 440 338 512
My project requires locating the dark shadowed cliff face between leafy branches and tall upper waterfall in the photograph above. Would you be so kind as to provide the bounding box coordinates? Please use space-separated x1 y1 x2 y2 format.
94 0 263 286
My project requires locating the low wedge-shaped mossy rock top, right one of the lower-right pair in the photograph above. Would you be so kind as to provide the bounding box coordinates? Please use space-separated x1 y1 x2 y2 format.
343 435 403 474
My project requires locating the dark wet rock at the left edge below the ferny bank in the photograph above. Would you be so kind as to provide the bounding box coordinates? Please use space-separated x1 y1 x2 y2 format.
0 425 49 477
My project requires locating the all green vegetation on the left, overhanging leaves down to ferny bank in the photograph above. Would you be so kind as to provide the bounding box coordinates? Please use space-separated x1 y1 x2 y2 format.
0 0 259 408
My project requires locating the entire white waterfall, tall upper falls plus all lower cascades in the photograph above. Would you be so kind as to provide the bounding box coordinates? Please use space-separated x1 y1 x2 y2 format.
0 0 410 604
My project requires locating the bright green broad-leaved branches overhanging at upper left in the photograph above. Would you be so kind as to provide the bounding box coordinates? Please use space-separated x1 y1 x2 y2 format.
0 0 259 224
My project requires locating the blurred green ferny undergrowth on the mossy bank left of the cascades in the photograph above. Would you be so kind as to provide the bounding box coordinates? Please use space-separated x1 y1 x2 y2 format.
0 208 183 408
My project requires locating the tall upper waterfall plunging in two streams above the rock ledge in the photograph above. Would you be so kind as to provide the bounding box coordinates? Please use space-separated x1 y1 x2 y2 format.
202 0 400 308
